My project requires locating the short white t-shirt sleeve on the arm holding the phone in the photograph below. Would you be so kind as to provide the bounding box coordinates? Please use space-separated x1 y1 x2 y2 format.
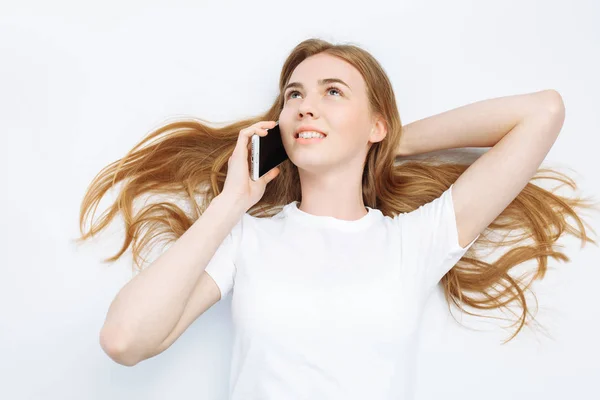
205 215 245 299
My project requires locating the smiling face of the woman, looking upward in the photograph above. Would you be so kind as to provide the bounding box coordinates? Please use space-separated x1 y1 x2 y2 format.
279 53 377 173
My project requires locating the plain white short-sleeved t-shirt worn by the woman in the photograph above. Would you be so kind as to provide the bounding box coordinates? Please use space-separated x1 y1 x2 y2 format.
206 186 479 400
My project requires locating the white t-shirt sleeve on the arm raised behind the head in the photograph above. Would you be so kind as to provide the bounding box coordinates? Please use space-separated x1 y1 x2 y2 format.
395 185 481 290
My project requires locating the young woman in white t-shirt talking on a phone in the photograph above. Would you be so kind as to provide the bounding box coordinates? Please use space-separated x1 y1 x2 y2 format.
81 39 595 400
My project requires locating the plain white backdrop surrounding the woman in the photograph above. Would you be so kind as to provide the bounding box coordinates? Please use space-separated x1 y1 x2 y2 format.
0 0 600 400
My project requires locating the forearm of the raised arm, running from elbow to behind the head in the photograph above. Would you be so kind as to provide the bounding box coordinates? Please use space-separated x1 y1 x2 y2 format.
397 90 560 156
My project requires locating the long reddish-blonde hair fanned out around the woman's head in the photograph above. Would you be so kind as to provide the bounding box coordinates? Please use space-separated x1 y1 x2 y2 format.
77 39 596 343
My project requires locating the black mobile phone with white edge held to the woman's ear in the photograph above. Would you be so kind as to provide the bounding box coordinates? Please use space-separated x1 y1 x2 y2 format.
250 121 288 181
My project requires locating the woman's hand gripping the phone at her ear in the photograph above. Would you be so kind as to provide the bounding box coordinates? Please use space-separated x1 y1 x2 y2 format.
221 121 279 210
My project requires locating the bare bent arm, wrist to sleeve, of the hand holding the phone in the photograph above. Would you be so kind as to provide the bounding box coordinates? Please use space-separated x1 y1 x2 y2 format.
100 195 247 366
